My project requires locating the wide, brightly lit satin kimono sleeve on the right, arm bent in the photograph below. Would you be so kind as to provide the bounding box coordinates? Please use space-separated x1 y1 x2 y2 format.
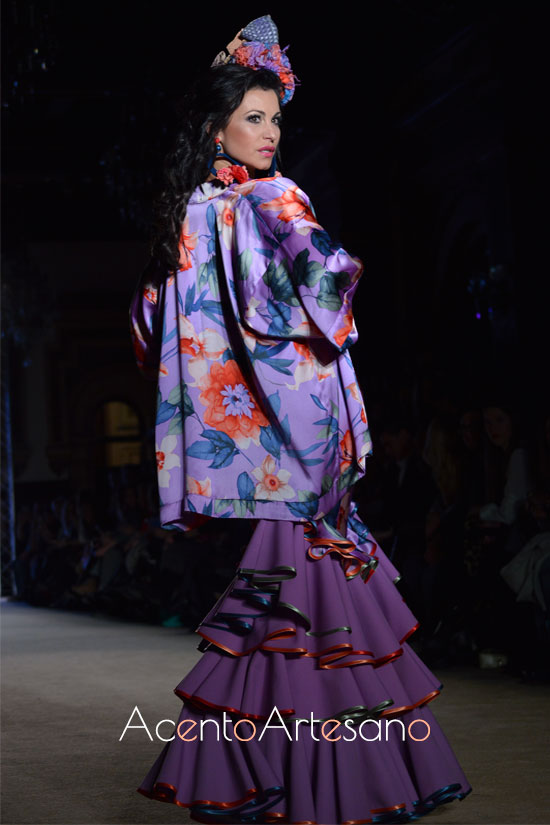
235 177 363 352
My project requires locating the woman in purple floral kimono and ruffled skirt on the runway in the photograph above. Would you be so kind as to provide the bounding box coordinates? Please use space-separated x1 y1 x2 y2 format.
131 17 471 823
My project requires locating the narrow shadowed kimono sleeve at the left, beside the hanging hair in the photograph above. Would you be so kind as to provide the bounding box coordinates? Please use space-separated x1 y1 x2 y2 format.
129 259 163 380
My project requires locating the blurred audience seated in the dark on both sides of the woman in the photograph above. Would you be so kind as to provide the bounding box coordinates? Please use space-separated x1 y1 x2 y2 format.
9 378 550 681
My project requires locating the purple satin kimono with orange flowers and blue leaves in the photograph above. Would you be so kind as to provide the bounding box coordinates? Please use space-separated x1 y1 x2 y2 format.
130 175 372 529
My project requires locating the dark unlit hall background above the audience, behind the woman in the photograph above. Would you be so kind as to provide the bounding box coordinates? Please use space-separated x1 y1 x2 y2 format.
2 0 548 540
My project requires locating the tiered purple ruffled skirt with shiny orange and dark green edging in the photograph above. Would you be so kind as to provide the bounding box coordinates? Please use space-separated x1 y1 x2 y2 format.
138 520 471 825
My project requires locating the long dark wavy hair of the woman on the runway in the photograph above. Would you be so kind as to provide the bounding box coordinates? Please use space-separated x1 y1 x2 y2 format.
151 63 282 270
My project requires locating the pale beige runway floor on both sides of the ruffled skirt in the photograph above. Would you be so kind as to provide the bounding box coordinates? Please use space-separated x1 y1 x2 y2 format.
0 599 550 825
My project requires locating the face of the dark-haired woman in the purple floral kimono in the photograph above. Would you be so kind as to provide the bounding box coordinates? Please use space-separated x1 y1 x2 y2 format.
215 89 281 174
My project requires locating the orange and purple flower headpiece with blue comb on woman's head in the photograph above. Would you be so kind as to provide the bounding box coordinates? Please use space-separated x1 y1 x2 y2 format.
212 14 299 106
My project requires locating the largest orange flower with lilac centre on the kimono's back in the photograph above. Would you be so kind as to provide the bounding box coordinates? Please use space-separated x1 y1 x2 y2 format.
197 360 269 448
